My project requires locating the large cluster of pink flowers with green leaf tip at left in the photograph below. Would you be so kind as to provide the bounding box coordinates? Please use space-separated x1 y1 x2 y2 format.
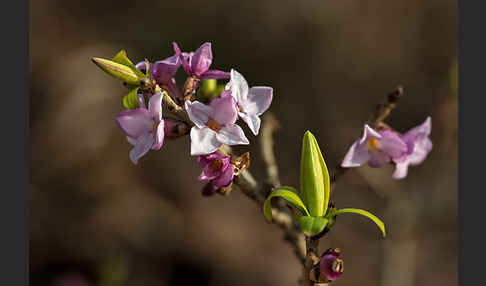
93 43 273 194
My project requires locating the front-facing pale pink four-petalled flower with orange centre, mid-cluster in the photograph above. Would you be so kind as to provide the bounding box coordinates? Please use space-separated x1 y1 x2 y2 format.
185 97 249 156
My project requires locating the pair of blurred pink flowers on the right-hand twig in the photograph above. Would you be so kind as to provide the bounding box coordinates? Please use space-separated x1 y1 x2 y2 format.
341 117 432 179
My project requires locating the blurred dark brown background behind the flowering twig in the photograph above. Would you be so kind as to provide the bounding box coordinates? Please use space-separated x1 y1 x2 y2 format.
30 0 458 286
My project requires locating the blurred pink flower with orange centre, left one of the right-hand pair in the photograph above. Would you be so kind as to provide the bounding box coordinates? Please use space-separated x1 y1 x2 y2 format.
341 124 407 168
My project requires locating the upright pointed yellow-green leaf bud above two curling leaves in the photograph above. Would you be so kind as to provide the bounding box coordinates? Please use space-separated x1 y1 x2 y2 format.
300 131 331 217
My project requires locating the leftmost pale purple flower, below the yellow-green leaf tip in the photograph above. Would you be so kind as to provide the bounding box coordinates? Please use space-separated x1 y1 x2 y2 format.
115 93 164 164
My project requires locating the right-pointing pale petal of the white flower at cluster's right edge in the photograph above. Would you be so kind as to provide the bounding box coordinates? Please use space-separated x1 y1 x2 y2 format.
238 86 273 115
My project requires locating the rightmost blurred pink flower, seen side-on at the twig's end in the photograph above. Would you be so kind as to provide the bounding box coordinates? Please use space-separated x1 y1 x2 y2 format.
392 116 432 179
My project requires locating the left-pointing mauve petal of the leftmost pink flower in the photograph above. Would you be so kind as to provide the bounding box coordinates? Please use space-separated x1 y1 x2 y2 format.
115 108 154 138
